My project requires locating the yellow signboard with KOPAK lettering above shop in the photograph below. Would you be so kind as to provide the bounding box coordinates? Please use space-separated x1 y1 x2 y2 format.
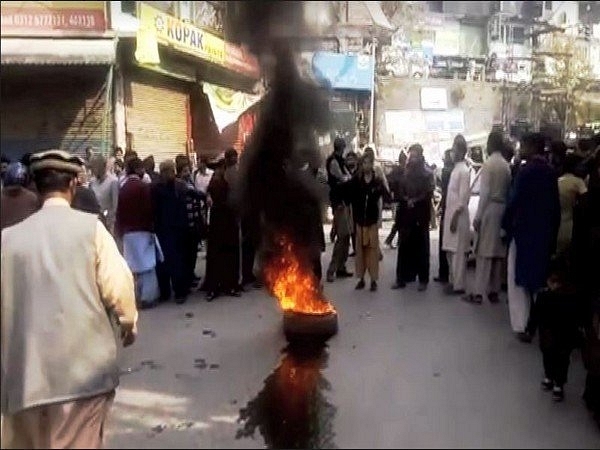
139 3 225 65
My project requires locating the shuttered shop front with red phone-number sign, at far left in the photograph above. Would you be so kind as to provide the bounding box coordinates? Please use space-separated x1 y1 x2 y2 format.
1 1 116 160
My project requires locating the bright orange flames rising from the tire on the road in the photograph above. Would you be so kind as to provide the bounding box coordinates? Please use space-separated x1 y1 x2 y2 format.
265 237 335 314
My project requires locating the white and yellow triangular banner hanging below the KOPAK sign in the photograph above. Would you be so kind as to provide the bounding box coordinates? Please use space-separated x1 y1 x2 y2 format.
202 83 261 133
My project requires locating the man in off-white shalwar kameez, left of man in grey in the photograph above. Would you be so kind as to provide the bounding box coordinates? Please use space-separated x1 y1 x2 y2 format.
442 134 471 295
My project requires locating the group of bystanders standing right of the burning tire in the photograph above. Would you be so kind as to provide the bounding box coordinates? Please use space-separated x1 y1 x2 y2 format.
327 131 600 422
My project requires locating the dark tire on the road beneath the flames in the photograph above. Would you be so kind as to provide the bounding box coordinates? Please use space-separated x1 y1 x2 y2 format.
283 311 338 342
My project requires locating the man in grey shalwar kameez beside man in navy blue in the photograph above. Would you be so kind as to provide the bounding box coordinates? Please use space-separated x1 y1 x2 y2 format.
464 131 511 304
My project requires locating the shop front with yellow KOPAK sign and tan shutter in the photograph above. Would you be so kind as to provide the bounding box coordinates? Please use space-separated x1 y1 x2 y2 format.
116 3 260 163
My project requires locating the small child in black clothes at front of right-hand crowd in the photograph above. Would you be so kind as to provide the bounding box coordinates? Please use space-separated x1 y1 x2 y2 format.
535 258 581 402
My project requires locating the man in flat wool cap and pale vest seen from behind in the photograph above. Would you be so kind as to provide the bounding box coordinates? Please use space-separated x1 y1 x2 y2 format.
0 150 137 448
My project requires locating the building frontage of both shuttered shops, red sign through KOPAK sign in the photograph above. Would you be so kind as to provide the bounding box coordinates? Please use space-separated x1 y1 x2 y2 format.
1 1 261 162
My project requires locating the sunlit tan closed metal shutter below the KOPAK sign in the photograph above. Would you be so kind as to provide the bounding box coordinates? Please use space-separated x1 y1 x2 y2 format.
125 70 189 164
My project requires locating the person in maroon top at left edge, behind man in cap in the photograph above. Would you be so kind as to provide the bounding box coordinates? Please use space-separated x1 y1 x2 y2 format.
0 162 41 229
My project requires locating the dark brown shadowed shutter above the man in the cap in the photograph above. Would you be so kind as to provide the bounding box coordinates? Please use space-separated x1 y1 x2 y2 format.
1 68 113 162
